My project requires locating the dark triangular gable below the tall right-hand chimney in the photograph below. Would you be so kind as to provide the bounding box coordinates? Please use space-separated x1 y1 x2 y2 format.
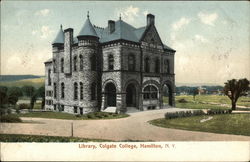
141 25 163 46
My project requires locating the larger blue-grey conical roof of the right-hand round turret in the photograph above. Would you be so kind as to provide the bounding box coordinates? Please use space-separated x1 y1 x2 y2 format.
78 15 98 37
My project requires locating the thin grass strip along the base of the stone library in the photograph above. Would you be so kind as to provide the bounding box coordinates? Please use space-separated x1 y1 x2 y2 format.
18 112 129 120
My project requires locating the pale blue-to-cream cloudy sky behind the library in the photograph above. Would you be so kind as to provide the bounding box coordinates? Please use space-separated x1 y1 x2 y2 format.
0 1 250 84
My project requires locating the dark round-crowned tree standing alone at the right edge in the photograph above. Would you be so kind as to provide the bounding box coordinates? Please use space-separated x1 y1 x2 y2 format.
224 78 250 110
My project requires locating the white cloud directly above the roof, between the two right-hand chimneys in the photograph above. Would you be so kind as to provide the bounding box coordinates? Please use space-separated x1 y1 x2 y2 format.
116 5 140 23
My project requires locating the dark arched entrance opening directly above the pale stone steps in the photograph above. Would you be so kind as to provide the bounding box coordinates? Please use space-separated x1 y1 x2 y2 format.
105 83 116 107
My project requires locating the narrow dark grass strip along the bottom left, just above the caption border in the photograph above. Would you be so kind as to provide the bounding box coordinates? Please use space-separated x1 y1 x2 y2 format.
0 134 109 142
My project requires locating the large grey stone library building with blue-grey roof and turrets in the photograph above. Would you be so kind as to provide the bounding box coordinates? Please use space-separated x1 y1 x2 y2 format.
45 14 175 114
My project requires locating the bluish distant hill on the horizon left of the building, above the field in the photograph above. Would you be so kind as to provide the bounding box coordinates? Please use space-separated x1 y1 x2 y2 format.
0 75 43 82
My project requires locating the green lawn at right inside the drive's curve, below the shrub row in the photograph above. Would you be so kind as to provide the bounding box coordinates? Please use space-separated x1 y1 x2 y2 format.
149 114 250 136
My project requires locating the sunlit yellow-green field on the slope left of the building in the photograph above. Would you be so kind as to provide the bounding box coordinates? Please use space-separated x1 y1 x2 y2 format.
0 77 44 88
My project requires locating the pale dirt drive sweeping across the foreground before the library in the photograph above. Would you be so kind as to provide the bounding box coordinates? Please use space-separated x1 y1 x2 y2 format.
0 108 250 141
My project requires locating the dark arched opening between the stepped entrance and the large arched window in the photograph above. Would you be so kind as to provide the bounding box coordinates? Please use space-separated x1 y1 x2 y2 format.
126 83 136 107
